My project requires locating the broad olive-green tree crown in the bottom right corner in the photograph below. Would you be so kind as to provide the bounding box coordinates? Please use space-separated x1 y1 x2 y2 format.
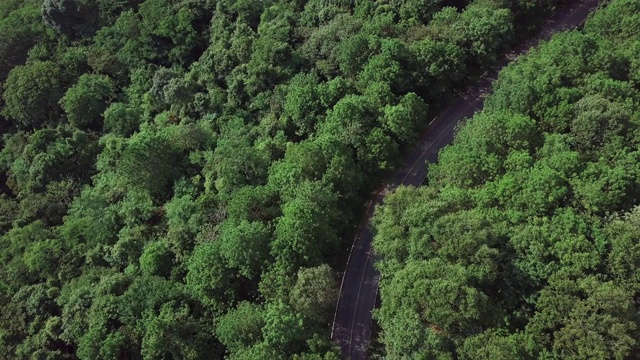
530 277 638 359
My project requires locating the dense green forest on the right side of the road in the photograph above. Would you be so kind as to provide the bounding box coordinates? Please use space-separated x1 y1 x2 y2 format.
374 0 640 360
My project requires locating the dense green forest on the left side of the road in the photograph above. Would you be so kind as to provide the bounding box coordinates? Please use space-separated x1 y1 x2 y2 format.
0 0 564 360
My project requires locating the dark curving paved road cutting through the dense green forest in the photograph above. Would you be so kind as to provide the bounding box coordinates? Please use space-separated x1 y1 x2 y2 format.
331 0 598 359
